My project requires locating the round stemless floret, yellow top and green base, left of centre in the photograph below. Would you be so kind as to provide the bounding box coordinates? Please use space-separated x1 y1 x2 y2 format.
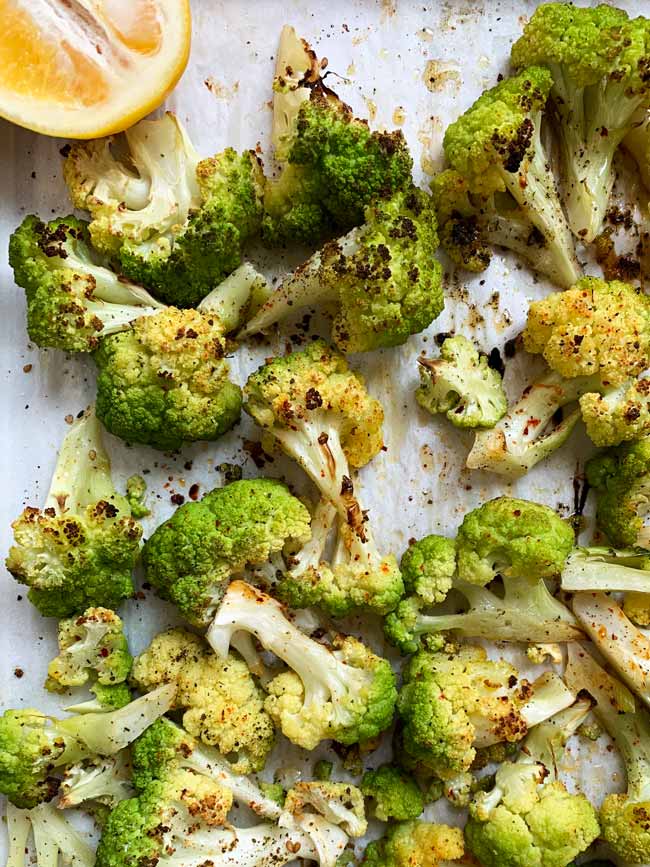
95 307 241 450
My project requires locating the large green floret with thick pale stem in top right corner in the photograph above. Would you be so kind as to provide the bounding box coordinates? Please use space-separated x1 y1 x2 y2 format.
511 3 650 243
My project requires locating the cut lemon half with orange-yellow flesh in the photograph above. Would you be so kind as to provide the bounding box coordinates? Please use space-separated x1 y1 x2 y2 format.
0 0 191 138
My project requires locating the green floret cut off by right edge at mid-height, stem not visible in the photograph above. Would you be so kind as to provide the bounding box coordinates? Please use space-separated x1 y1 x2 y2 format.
585 437 650 548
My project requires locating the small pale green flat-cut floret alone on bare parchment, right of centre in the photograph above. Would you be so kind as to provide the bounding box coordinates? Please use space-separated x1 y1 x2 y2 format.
415 335 508 428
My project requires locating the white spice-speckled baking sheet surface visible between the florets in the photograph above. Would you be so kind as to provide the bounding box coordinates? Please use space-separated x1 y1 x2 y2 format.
0 0 647 860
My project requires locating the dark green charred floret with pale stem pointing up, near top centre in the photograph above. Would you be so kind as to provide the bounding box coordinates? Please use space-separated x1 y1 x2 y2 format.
262 27 413 244
